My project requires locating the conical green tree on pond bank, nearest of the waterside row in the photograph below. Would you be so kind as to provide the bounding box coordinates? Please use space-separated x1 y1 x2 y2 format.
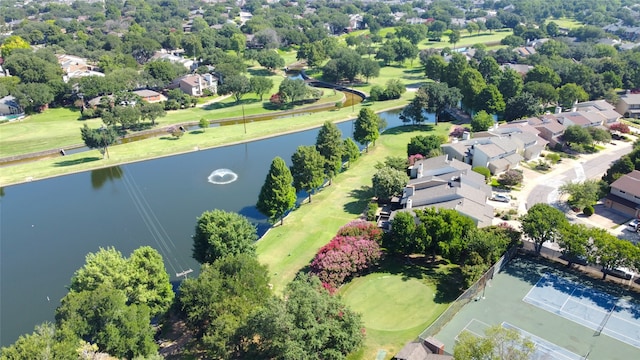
256 157 296 225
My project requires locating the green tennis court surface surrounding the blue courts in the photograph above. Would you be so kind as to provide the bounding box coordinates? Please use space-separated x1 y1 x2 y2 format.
434 256 640 360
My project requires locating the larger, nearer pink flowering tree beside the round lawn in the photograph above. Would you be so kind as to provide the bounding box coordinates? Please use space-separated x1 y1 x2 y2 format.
311 235 381 292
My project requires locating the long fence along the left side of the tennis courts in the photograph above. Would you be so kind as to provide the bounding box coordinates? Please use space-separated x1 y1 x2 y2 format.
418 244 520 341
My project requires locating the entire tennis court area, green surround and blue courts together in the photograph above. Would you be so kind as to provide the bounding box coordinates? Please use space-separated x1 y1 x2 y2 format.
430 255 640 360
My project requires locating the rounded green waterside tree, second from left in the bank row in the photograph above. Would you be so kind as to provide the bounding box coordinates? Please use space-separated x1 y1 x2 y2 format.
291 146 325 202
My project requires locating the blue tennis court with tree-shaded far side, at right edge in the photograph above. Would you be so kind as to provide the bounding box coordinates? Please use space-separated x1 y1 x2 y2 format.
522 274 640 348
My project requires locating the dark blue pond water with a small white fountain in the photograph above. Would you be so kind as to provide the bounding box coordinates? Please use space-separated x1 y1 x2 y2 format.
0 107 410 346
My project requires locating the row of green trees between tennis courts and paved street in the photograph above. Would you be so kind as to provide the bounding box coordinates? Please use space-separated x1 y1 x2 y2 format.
521 204 640 279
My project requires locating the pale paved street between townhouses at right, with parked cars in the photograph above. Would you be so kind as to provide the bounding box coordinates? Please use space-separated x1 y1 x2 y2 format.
521 141 632 208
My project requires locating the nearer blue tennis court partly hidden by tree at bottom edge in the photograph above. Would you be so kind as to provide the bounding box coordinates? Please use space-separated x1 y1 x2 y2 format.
456 319 583 360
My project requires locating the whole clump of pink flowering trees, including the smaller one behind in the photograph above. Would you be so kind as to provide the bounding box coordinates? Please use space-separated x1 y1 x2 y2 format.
310 220 382 292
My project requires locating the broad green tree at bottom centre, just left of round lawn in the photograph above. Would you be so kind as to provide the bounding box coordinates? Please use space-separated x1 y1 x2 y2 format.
239 274 364 360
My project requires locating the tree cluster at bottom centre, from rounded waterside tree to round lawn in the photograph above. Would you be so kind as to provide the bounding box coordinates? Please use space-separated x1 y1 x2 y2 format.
178 210 363 359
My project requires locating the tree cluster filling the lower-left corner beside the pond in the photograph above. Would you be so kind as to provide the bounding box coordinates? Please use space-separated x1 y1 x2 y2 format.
0 246 174 359
